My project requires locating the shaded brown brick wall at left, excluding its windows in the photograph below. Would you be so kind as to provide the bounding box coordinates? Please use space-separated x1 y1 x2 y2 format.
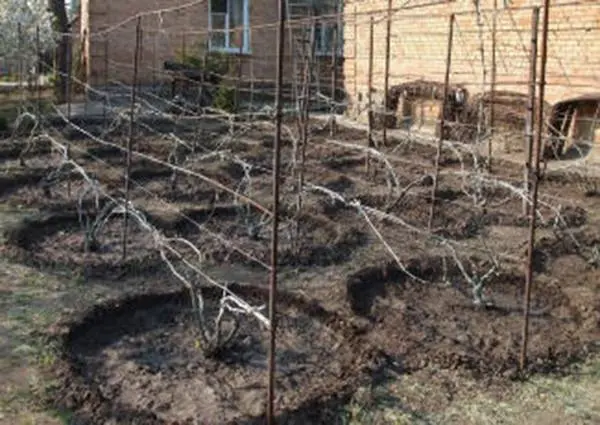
81 0 343 95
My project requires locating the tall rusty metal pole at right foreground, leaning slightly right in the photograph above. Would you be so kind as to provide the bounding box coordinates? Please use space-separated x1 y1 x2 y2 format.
519 0 550 373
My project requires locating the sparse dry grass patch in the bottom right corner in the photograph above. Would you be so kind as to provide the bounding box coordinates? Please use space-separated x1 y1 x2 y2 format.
340 356 600 425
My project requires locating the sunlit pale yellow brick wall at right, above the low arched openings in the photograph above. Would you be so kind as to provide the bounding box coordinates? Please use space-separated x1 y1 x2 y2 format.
344 0 600 119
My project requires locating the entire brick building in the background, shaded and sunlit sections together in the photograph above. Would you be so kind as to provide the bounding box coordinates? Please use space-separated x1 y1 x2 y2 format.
80 0 600 152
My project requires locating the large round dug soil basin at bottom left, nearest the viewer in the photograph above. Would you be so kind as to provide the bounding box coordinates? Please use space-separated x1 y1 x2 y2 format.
57 286 372 425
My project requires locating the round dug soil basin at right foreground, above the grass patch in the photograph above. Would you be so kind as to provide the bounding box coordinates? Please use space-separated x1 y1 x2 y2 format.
347 258 600 376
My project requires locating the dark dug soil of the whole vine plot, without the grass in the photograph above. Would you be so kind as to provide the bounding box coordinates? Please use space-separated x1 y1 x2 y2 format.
2 115 600 425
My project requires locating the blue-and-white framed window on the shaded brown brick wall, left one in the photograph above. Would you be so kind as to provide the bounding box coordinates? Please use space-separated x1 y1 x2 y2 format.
208 0 250 53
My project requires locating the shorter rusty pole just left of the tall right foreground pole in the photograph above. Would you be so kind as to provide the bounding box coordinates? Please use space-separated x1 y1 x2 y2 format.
523 7 540 216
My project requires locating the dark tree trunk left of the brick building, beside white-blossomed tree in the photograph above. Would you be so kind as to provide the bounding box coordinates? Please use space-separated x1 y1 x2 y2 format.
48 0 71 103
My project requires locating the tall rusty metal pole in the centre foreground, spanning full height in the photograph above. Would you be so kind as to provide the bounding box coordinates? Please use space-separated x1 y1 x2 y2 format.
267 0 286 425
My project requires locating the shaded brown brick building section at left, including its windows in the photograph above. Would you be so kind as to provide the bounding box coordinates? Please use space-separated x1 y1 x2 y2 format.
80 0 343 92
